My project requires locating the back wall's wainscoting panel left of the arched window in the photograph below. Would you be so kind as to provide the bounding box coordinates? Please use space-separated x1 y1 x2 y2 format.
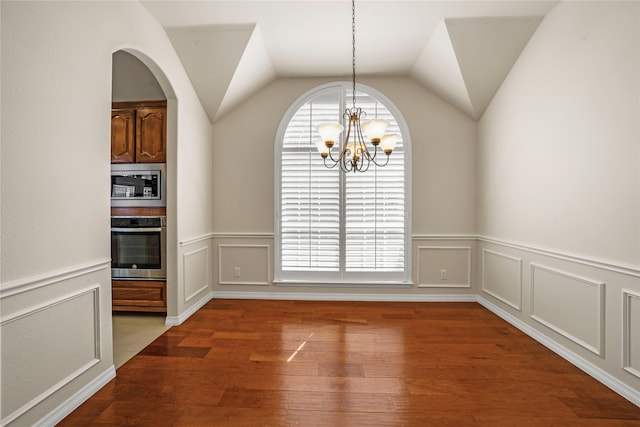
218 244 271 286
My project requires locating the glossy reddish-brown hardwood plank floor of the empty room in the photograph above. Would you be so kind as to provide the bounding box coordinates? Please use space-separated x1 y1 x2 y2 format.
60 300 640 427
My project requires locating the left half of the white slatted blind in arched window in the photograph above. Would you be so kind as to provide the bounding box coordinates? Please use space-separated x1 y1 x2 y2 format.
280 100 340 271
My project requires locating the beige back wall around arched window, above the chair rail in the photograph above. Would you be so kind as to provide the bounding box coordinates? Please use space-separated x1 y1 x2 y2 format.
213 78 476 235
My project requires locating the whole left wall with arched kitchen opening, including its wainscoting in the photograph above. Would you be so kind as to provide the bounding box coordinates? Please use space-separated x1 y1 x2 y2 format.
0 1 212 425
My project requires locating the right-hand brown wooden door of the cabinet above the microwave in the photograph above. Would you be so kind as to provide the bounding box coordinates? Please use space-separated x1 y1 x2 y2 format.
136 108 167 163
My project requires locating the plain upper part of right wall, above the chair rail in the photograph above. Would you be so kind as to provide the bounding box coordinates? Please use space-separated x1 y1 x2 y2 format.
478 2 640 268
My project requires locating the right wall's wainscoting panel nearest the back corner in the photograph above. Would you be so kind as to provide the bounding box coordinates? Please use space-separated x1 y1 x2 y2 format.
481 249 522 311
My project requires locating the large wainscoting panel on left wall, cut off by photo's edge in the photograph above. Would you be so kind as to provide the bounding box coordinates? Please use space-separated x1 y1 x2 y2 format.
1 285 100 425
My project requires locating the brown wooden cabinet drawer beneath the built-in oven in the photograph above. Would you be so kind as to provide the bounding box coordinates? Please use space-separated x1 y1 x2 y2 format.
111 280 167 313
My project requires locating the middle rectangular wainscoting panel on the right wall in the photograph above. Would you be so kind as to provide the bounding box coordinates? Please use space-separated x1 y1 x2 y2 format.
531 263 605 357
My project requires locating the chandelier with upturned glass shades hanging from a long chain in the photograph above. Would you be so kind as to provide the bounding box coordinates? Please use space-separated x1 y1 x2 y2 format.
316 0 400 172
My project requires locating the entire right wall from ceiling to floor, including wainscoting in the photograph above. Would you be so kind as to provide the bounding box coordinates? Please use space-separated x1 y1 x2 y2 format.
476 2 640 405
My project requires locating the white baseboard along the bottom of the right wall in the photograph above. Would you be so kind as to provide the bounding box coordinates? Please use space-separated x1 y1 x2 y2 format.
477 295 640 406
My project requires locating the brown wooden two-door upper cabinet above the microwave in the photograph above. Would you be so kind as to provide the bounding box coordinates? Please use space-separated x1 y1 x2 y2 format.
111 101 167 163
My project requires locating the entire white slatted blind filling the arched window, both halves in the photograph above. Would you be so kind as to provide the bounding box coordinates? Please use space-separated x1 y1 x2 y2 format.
279 88 406 280
